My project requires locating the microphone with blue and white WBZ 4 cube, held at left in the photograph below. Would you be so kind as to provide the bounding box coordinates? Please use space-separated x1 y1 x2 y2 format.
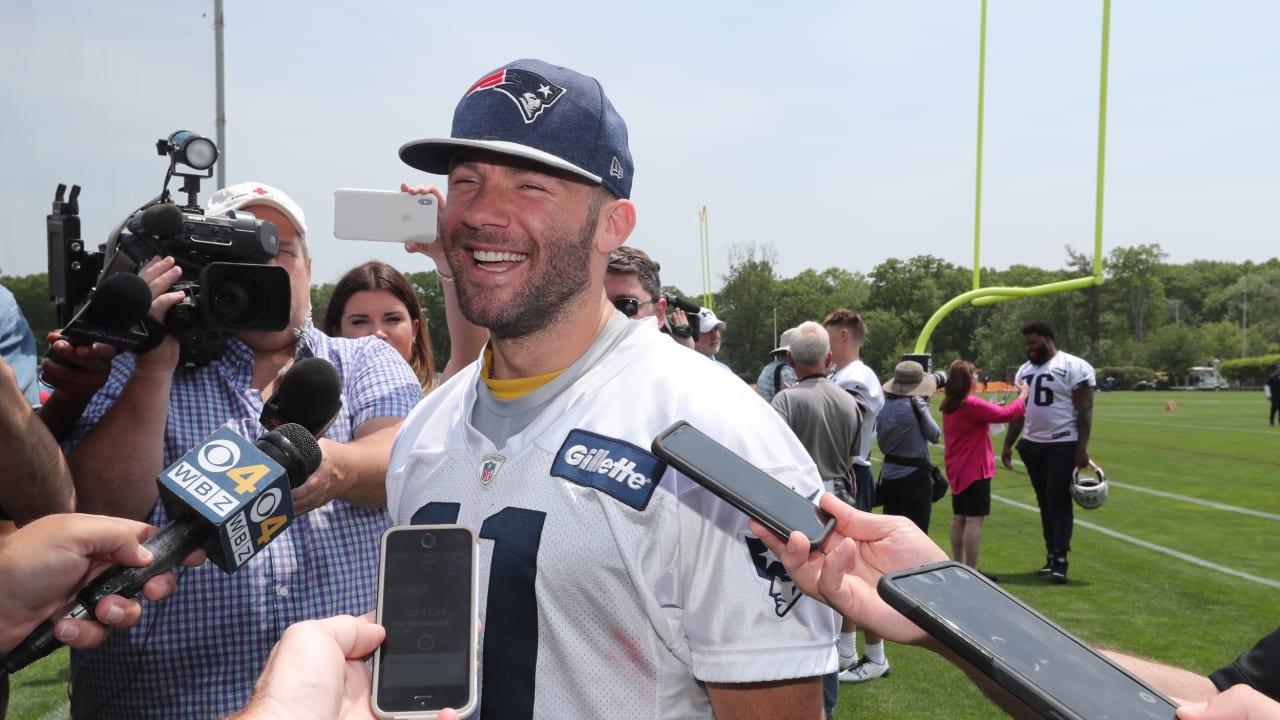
0 423 321 675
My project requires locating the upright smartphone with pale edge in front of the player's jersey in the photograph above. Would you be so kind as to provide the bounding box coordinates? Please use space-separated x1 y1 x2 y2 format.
372 525 477 719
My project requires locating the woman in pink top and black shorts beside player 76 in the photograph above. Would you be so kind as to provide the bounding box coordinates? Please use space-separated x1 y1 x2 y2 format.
941 360 1028 569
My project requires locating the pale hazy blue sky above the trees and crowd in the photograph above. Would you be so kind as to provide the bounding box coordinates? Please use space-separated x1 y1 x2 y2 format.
0 0 1280 293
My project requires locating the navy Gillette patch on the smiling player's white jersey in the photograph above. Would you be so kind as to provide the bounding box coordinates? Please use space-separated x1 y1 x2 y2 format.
552 429 667 510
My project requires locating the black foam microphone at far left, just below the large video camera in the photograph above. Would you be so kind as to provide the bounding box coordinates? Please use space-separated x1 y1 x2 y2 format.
45 273 152 363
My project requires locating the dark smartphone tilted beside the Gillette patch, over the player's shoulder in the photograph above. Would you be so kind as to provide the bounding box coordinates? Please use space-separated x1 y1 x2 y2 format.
653 420 836 547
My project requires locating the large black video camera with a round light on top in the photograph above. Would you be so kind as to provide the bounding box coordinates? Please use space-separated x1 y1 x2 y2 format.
46 131 292 366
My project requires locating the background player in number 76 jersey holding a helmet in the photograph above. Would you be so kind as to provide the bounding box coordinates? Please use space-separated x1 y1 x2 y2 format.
1000 323 1097 584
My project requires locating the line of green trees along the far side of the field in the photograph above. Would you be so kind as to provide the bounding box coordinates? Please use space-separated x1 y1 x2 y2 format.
0 243 1280 384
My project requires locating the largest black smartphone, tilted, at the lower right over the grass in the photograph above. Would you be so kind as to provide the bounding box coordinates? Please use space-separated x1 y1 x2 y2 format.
877 562 1178 720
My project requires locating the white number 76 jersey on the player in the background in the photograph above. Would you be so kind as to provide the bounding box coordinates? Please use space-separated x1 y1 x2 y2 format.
1018 350 1097 442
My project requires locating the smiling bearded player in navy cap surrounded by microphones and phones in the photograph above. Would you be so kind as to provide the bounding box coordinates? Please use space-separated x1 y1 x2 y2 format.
387 60 836 720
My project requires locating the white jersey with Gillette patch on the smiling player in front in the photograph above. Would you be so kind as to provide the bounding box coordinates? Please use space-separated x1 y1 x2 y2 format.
387 323 836 720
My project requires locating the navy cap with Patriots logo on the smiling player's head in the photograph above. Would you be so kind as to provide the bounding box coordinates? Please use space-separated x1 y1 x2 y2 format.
399 59 635 197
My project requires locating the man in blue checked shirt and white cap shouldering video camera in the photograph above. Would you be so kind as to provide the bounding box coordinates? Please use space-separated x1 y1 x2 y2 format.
68 183 422 719
